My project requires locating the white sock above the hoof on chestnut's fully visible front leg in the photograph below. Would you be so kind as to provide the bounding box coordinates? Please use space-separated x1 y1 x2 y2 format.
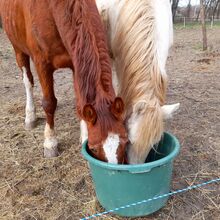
44 123 58 149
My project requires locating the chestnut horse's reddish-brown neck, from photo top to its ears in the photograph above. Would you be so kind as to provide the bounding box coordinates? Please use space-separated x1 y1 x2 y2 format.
49 0 114 105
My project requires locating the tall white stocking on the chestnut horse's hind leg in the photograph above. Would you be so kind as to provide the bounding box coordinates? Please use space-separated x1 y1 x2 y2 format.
22 67 36 125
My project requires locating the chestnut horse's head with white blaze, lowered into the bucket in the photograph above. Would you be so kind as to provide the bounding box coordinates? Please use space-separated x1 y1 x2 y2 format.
83 97 128 164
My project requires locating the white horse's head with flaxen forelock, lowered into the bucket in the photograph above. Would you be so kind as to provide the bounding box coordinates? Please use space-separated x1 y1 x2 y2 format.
127 100 180 164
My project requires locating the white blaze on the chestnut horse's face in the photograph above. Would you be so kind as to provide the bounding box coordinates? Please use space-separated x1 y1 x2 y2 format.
103 133 120 164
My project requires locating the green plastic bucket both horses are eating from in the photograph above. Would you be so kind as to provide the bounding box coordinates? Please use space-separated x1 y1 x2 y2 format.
82 133 180 217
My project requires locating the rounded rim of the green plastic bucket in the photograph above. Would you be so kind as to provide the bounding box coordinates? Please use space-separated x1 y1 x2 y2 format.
81 132 180 173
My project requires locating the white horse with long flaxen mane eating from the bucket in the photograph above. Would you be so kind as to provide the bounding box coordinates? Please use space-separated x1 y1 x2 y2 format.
96 0 179 164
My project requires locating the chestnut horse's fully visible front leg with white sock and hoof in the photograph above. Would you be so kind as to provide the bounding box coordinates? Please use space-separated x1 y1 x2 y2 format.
36 64 59 157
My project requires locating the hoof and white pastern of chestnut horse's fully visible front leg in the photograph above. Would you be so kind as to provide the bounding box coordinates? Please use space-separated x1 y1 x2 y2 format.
44 138 59 158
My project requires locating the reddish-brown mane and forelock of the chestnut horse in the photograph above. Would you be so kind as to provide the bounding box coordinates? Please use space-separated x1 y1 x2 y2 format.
49 0 115 131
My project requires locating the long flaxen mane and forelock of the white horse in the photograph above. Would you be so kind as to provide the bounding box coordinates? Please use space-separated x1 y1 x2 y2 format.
112 0 166 161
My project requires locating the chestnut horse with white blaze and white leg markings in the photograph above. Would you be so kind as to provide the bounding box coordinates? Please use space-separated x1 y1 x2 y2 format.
0 0 128 163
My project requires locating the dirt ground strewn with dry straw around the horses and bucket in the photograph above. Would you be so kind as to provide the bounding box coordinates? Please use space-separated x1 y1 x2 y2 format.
0 28 220 220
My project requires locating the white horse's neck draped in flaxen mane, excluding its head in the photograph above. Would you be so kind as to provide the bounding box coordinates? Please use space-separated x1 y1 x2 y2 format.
102 0 170 109
